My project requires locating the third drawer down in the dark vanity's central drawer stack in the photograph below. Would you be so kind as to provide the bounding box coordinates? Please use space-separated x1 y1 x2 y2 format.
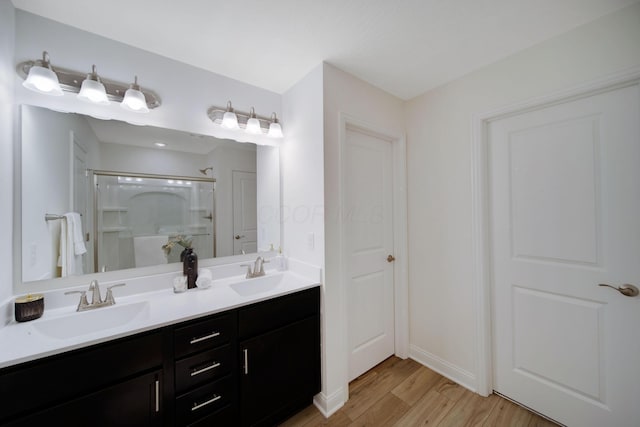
176 375 235 425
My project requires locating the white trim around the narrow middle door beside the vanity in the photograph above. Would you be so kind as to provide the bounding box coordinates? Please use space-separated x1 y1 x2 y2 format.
338 112 409 397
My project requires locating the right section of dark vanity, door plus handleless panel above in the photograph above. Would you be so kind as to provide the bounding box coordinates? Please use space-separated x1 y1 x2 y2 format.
239 288 320 426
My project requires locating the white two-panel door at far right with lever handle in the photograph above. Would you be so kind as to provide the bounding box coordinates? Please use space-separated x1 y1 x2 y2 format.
488 85 640 427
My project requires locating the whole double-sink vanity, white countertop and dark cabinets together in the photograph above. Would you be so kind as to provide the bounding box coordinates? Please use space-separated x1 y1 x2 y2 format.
0 263 321 427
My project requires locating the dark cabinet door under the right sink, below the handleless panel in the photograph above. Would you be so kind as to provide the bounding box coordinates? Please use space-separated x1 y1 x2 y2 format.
240 316 320 426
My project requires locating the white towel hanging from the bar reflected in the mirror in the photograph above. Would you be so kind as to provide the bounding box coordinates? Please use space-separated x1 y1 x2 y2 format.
58 212 87 277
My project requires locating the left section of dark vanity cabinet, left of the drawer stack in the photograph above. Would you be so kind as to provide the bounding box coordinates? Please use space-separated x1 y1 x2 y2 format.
0 332 164 427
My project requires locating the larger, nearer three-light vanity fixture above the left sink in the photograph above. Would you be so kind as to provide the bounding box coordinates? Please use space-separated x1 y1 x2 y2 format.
16 52 160 113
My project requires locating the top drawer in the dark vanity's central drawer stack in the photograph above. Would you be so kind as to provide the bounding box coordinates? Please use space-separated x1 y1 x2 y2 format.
174 313 235 358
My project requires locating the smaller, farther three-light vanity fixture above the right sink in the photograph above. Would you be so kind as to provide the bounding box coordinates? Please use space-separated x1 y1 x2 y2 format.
207 101 283 138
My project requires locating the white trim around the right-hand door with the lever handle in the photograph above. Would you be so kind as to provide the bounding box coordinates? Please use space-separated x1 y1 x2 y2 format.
471 68 640 396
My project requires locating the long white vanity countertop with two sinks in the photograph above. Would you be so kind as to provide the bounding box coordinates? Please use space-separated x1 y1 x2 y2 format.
0 260 320 368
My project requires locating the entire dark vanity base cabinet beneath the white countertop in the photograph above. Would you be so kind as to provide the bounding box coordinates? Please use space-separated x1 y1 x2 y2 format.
0 270 320 426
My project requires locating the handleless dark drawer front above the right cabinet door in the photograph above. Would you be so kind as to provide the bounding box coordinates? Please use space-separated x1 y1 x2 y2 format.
238 286 320 339
